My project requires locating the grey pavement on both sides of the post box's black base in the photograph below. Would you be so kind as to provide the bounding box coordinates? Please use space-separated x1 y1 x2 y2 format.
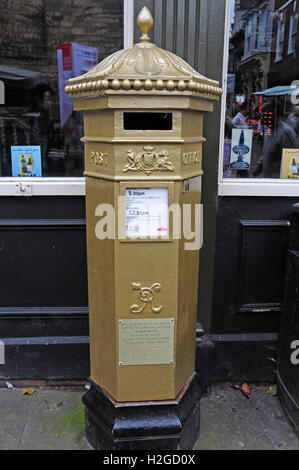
0 383 299 450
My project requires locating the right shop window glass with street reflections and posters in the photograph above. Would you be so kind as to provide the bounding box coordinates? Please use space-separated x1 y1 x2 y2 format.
223 0 299 180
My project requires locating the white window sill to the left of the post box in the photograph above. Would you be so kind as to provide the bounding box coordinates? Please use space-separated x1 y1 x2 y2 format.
0 177 85 197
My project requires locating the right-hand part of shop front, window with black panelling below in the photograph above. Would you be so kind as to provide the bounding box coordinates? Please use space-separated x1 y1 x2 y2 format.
211 0 299 380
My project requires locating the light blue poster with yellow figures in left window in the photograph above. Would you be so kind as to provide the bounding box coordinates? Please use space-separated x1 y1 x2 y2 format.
11 145 42 178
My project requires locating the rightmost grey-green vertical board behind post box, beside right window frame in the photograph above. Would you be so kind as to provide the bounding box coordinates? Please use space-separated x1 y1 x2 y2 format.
195 0 226 333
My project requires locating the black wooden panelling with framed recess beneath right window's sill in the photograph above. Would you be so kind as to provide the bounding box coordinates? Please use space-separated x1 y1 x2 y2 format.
212 197 296 335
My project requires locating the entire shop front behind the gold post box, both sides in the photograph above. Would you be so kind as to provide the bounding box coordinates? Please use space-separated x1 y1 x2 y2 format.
0 0 299 422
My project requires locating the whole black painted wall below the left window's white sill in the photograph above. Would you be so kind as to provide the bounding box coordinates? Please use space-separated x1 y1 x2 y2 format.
0 197 89 379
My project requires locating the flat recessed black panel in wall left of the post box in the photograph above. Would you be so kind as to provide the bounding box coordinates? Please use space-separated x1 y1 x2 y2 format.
0 219 87 307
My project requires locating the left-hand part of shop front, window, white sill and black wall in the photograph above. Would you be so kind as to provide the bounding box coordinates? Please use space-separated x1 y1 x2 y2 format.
0 0 123 379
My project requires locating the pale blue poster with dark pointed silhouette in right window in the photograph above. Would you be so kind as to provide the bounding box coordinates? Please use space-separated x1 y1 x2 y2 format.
230 129 253 170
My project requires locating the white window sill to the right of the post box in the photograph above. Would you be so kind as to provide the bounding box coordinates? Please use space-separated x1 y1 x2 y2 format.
218 179 299 197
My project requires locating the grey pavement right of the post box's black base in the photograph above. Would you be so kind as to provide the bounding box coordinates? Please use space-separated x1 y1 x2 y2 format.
195 383 299 450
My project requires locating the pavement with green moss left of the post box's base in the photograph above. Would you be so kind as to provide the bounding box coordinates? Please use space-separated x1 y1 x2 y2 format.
0 389 91 450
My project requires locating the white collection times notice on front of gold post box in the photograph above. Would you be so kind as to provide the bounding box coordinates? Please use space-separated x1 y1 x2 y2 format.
126 188 169 238
